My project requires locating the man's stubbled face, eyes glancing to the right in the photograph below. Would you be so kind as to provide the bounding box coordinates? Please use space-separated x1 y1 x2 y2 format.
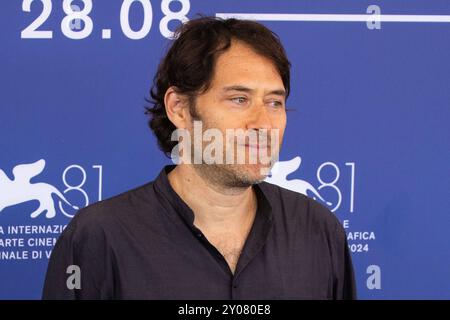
191 41 286 187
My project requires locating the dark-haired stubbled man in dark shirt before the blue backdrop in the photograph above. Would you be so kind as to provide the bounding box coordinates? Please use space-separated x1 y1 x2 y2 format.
43 17 355 299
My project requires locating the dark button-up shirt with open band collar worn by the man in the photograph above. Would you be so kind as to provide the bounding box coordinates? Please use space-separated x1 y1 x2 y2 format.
43 166 356 299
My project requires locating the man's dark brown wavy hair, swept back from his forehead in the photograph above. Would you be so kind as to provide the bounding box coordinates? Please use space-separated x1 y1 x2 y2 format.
145 17 290 157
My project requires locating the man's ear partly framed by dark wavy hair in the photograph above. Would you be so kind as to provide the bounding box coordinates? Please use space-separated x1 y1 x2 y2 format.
164 86 191 129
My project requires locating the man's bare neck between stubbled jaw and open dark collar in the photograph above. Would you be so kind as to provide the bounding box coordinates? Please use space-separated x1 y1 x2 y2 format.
168 165 256 233
